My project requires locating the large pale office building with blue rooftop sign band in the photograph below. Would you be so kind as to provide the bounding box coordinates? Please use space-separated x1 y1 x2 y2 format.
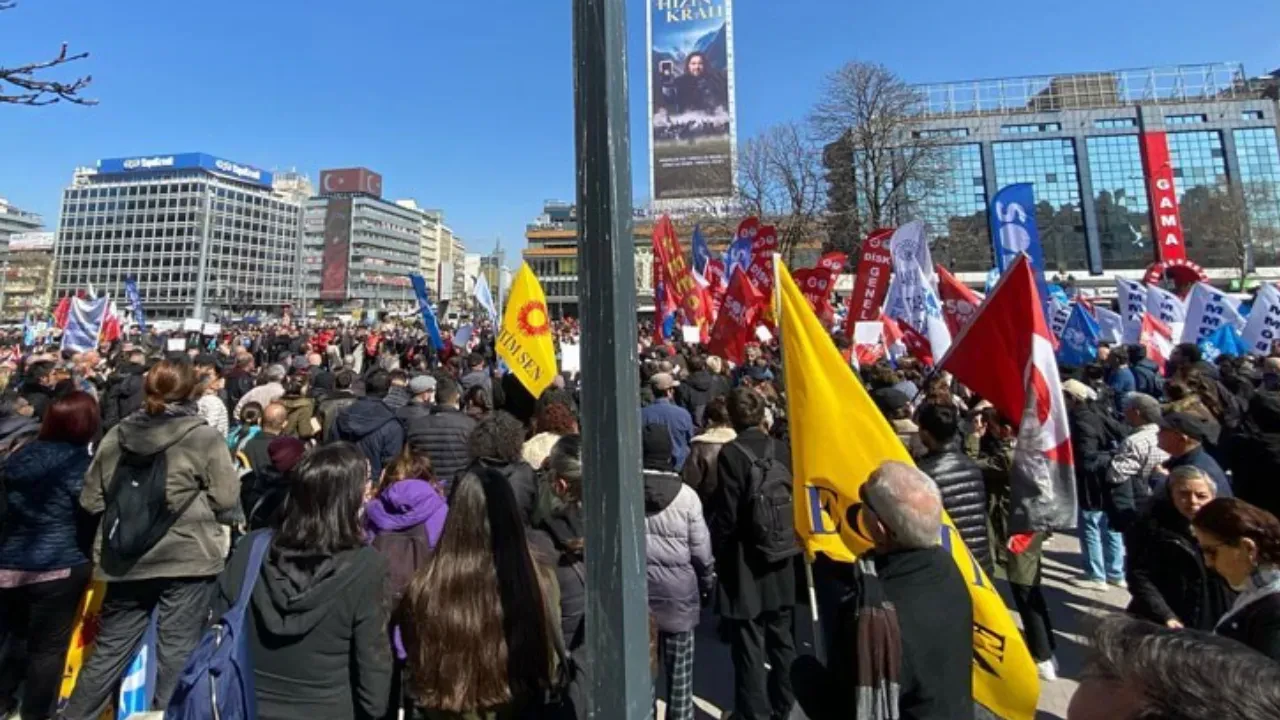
54 152 301 319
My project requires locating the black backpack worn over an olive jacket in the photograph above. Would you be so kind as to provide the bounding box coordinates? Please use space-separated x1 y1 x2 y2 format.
102 424 200 565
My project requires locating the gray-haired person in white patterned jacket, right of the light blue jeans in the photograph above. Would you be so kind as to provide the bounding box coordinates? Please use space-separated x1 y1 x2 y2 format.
1107 392 1169 533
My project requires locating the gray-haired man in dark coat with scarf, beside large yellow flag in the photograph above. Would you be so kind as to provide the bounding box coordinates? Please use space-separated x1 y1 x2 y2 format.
791 462 974 720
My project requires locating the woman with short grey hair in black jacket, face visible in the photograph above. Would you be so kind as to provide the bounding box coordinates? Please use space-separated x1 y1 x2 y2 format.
1125 465 1234 630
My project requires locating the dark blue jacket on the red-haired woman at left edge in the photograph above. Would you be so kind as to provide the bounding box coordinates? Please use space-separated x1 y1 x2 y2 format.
0 441 90 570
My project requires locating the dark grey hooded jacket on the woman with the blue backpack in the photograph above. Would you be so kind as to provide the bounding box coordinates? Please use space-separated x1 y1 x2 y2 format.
212 533 392 720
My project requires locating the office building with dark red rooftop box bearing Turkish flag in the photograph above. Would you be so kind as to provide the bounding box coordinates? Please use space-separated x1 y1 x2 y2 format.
302 168 422 311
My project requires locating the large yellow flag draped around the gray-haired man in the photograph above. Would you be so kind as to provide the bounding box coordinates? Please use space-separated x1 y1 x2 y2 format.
777 260 1039 720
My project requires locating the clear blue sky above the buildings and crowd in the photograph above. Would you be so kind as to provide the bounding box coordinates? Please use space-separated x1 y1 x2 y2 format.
0 0 1280 251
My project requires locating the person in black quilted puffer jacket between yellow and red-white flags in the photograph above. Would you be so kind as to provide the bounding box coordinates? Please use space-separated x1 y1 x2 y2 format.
915 404 996 577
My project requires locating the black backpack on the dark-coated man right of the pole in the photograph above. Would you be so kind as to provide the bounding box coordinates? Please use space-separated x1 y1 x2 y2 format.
739 441 800 562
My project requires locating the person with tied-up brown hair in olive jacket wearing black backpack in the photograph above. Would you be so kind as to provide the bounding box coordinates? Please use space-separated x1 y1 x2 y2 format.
63 359 239 720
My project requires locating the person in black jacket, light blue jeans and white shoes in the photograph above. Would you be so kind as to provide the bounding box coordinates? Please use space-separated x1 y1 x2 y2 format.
1062 379 1126 589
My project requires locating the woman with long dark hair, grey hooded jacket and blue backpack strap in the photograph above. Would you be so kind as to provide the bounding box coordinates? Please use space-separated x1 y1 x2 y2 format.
212 443 392 720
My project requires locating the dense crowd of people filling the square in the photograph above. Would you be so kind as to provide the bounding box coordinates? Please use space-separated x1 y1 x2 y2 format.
0 327 1280 720
